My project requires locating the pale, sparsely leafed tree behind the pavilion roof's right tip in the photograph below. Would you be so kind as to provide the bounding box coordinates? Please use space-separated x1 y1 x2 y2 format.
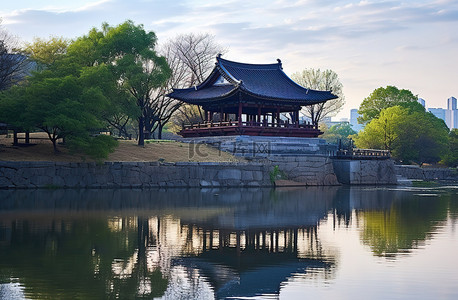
291 69 345 125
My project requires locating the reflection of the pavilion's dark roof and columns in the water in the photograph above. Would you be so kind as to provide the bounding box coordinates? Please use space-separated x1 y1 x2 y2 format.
175 225 335 299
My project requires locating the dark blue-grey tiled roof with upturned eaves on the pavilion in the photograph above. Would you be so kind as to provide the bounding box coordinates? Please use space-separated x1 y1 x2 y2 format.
169 56 337 105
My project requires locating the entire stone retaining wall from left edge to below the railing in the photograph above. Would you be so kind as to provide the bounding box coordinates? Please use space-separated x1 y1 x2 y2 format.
0 156 406 189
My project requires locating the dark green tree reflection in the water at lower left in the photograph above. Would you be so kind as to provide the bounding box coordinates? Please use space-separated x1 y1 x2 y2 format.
0 217 167 299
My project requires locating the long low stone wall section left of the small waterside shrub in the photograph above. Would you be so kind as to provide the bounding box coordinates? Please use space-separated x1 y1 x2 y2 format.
0 162 271 188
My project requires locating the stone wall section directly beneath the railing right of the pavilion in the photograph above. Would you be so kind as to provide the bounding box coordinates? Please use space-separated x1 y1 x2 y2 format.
333 159 397 185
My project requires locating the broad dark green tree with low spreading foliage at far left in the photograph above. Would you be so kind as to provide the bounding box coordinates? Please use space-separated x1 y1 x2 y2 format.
0 65 116 158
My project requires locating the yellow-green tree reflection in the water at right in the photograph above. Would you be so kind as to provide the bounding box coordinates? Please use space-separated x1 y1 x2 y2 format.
358 196 450 257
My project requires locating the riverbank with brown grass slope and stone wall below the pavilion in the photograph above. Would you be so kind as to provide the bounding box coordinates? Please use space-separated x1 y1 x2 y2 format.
0 134 456 189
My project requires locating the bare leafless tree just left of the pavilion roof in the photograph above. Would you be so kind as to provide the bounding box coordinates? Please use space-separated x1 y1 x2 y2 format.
145 33 226 139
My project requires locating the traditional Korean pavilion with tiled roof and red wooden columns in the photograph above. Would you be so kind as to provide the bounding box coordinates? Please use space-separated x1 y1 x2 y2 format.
169 55 337 137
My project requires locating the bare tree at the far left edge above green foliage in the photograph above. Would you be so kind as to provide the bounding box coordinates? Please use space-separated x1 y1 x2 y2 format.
0 20 33 91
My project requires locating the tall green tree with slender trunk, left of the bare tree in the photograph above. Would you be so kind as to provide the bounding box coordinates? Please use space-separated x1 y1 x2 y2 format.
68 21 171 145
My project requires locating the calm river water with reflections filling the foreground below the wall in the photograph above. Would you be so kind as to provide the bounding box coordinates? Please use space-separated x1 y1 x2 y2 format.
0 186 458 300
